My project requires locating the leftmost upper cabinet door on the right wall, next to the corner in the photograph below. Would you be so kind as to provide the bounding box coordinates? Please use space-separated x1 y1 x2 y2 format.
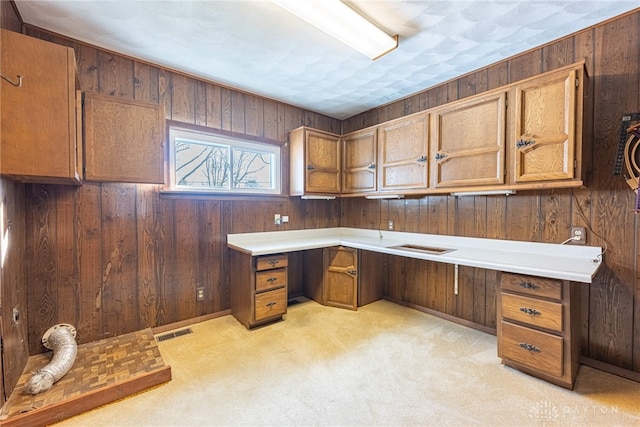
342 128 378 193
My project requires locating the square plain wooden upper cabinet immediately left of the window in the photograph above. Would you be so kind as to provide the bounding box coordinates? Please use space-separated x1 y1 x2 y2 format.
84 93 165 184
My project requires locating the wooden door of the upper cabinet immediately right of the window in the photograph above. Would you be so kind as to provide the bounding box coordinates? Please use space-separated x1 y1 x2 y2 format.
305 129 340 194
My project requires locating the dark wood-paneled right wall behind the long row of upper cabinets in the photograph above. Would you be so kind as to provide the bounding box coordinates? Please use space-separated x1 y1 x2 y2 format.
342 10 640 372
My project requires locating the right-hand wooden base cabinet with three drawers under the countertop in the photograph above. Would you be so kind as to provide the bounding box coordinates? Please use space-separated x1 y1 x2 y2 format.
497 273 580 389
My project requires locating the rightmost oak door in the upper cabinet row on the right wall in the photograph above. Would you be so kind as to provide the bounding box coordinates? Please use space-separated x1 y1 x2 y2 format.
510 69 583 182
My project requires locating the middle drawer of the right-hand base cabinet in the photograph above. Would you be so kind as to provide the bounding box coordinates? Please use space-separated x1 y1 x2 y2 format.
500 292 562 332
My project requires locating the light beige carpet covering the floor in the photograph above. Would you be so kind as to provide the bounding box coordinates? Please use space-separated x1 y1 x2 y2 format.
58 301 640 426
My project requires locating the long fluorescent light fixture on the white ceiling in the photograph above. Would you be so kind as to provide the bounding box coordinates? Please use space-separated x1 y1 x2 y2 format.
271 0 398 59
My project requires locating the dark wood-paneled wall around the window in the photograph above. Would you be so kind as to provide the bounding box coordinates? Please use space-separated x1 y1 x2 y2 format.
18 27 340 353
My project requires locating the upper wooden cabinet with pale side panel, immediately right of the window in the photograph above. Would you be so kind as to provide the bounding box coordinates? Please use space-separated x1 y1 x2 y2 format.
289 126 341 196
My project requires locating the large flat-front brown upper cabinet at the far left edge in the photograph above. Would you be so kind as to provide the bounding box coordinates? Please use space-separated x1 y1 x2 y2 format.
0 30 82 184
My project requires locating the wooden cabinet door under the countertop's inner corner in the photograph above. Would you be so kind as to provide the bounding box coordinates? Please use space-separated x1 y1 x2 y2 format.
323 247 358 310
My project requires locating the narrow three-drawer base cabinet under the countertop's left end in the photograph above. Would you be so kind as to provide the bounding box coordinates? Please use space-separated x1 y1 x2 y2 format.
231 251 289 329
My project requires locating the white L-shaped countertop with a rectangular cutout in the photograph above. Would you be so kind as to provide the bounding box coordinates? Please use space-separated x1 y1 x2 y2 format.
227 227 602 283
